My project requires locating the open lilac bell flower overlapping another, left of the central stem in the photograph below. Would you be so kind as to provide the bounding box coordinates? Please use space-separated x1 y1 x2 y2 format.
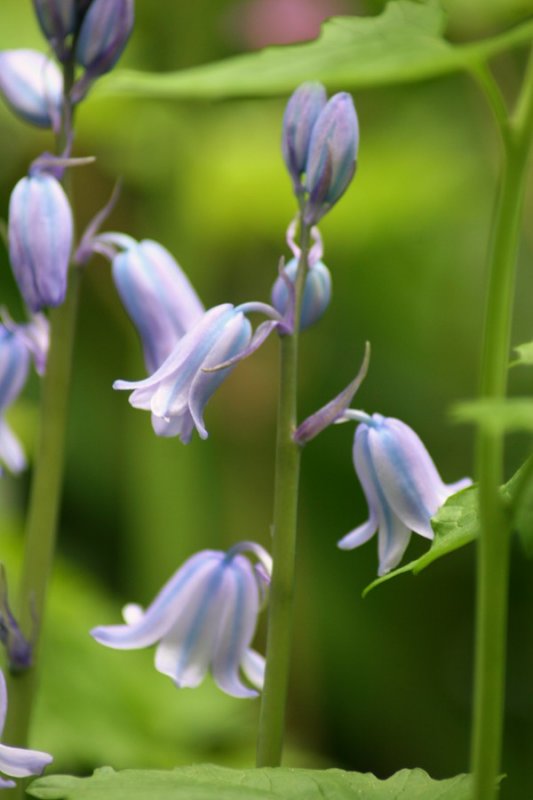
113 303 280 444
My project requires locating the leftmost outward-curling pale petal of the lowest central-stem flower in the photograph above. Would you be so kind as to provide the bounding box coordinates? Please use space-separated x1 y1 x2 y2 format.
91 550 224 650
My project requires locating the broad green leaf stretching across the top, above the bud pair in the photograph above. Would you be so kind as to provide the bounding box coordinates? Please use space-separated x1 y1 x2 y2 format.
98 0 533 98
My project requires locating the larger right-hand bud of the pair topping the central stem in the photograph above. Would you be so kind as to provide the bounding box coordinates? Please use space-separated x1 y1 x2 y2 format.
304 92 359 225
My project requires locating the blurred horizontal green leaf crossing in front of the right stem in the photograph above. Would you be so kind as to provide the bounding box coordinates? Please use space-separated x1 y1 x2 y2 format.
452 397 533 434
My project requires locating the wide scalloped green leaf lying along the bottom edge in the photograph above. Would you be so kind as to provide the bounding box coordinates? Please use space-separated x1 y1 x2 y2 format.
27 764 471 800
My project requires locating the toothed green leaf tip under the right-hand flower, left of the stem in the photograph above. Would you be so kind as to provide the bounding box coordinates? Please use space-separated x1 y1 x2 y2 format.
363 486 479 597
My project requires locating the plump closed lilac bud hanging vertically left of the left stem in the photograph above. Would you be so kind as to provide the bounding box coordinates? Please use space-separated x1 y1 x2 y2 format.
8 173 73 312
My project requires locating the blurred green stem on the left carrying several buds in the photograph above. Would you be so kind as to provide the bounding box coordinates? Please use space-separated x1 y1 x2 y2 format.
5 64 80 756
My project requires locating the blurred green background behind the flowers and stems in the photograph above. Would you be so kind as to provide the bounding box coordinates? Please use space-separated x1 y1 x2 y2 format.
0 0 533 800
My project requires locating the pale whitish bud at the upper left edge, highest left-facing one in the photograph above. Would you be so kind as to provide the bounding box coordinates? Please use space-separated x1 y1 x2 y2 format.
0 50 63 129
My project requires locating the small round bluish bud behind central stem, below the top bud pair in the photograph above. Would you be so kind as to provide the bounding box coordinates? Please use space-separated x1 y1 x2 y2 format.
271 258 331 330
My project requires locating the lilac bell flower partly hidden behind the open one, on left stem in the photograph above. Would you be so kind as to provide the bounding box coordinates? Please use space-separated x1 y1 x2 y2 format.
109 234 204 373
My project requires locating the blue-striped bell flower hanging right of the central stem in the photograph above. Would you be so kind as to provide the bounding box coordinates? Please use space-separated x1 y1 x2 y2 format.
339 410 472 575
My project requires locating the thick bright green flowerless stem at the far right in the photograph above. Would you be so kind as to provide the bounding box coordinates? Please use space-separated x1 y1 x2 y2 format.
471 51 533 800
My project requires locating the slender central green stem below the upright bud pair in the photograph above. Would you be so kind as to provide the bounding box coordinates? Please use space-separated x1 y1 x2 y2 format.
257 216 310 767
